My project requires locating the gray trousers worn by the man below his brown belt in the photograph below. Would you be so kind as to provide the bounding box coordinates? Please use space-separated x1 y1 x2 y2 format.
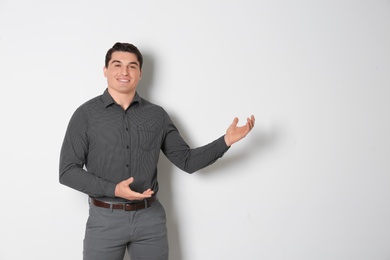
83 200 168 260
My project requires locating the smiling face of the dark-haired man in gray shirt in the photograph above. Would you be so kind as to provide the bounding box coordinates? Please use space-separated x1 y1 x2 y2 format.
104 51 142 94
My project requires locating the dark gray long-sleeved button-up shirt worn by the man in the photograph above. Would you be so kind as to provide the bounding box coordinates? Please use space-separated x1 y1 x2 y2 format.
59 89 229 201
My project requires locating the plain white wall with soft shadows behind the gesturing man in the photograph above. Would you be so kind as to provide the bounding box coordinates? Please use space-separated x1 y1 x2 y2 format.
0 0 390 260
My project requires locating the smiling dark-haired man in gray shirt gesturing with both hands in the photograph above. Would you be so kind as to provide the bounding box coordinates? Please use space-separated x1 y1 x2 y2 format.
60 43 255 260
